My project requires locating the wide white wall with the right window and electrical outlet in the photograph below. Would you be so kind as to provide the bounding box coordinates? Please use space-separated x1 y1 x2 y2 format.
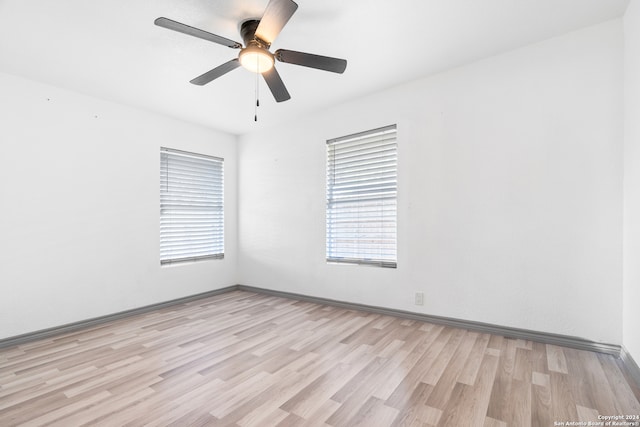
238 20 623 344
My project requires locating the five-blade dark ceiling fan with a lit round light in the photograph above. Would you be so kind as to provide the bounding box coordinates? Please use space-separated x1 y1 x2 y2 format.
154 0 347 102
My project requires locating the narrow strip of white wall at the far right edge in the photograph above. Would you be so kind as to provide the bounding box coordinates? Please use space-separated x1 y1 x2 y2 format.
623 0 640 363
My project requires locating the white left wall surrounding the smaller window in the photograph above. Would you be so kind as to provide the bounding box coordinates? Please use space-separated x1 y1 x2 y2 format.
0 74 237 338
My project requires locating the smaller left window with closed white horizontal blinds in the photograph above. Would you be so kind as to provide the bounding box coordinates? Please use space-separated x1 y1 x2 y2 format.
160 148 224 264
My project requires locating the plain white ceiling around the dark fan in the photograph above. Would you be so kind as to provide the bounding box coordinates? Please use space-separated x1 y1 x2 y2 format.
0 0 629 134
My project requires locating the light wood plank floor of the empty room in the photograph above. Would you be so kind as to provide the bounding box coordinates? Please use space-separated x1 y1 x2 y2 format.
0 291 640 427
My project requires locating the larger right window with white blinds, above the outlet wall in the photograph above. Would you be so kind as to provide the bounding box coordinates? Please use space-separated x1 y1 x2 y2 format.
327 125 397 267
